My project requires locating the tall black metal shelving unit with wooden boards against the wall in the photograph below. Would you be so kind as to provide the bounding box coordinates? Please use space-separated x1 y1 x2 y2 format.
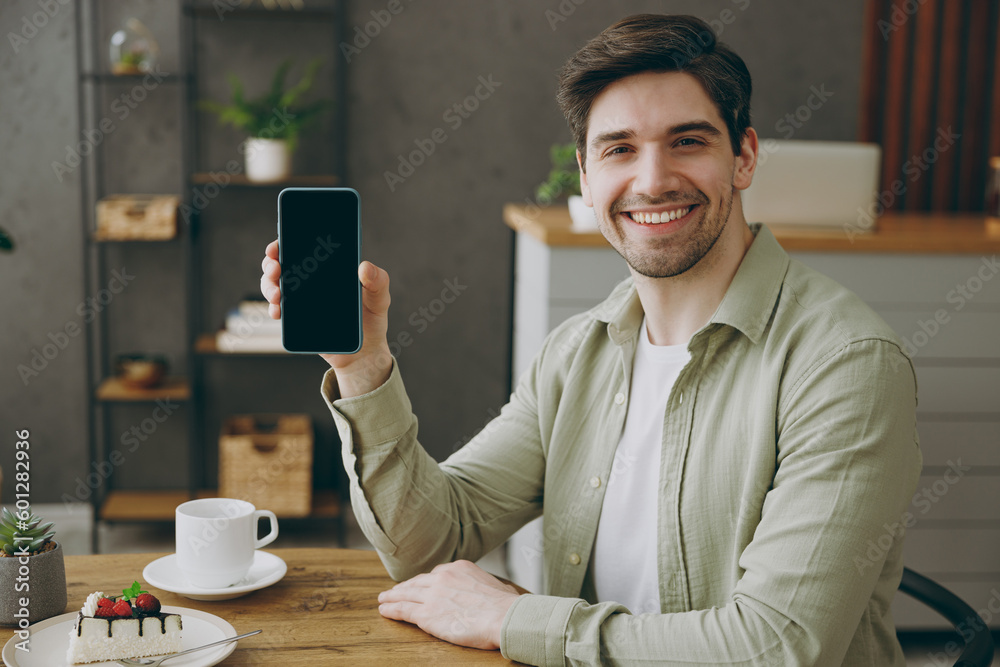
76 0 347 553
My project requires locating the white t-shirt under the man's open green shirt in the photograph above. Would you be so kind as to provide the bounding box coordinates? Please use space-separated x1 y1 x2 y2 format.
590 318 690 614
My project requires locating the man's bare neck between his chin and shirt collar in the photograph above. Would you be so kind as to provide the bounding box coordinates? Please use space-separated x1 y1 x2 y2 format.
632 219 754 345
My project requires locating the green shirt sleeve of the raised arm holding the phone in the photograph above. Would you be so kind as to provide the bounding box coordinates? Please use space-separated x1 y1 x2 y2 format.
322 359 545 581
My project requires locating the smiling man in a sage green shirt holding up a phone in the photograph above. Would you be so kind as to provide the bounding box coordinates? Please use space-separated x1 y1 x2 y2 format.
262 15 920 667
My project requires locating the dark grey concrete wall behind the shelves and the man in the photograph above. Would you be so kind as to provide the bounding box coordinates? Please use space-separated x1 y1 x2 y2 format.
0 0 862 501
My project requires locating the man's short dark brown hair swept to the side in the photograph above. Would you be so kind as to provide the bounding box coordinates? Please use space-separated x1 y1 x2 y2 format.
556 14 752 165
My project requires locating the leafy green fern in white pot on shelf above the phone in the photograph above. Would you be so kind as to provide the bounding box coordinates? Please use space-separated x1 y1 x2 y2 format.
199 59 328 182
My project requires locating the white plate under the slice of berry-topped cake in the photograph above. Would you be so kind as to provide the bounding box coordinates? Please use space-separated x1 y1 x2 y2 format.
3 607 238 667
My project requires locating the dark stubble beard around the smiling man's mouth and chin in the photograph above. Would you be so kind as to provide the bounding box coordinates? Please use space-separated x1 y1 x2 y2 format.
604 190 733 278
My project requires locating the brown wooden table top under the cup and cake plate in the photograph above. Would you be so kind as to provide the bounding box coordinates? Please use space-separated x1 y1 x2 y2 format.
0 549 515 667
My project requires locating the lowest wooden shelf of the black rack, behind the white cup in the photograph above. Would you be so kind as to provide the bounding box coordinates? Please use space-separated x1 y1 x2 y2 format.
99 489 340 522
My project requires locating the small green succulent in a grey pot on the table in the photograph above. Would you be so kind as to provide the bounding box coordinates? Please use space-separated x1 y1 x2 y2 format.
0 507 66 629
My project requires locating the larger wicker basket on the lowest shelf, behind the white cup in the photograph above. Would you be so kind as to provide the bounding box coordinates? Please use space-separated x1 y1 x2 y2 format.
219 415 313 517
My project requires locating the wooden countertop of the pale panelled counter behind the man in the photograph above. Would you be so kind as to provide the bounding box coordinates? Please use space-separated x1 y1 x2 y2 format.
503 204 1000 254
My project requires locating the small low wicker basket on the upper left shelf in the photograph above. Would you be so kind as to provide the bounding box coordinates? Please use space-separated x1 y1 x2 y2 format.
94 195 180 241
